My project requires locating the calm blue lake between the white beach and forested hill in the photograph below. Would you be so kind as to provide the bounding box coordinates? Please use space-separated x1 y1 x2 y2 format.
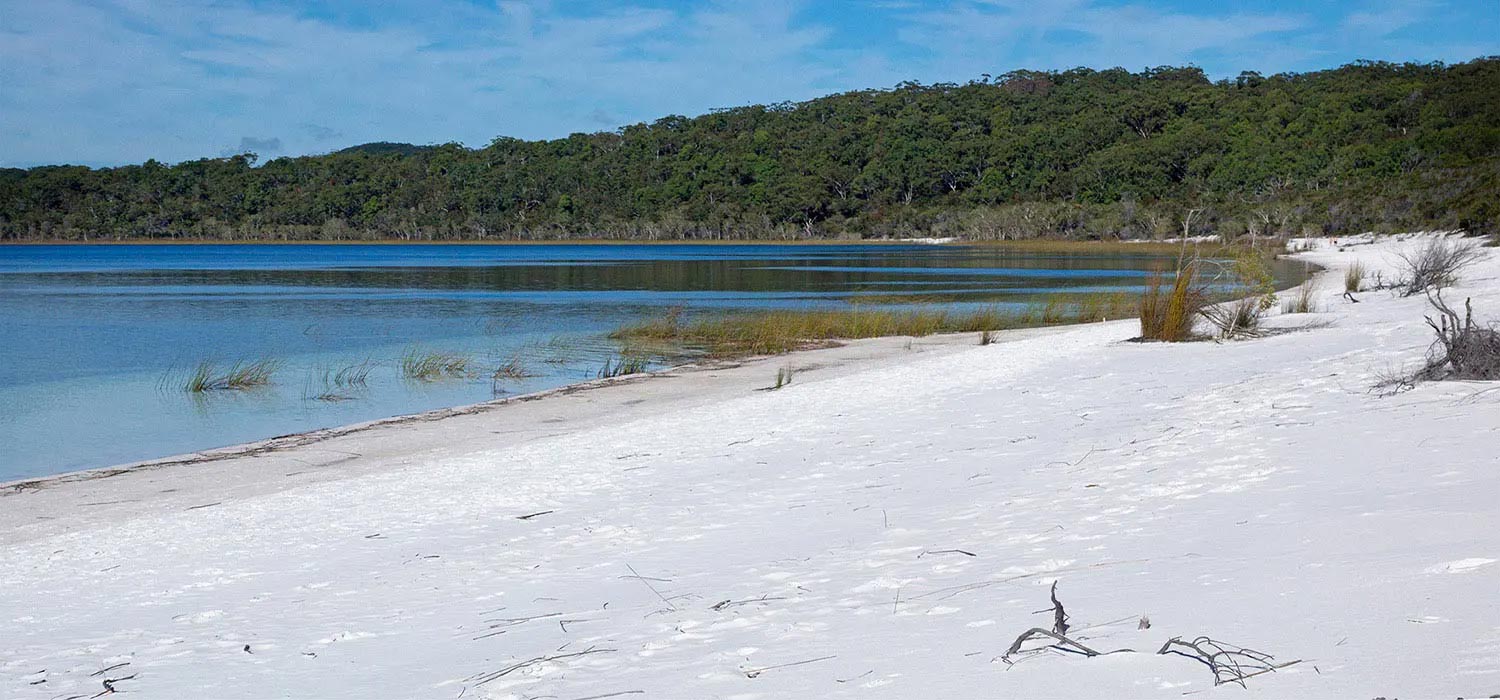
0 244 1290 481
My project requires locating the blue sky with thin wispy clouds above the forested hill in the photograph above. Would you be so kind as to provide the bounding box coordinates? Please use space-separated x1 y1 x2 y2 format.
0 0 1500 168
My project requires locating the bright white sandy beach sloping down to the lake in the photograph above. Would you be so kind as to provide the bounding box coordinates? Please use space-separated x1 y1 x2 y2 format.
0 233 1500 700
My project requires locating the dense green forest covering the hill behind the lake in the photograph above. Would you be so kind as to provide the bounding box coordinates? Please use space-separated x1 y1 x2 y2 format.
0 57 1500 240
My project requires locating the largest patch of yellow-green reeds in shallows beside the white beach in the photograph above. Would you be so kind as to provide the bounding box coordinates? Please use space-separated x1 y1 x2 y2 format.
611 307 1020 357
